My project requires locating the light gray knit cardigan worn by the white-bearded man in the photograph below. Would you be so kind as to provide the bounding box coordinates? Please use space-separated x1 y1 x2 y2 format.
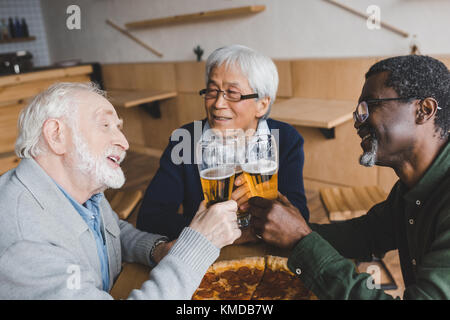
0 159 219 300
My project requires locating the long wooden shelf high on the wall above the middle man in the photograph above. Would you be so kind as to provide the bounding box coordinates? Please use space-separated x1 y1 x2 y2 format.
125 5 266 29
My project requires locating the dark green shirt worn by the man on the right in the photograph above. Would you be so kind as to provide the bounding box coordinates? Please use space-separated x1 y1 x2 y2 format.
288 143 450 299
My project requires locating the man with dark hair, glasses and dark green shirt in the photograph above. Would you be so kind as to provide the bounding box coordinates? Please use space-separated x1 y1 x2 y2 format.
250 55 450 299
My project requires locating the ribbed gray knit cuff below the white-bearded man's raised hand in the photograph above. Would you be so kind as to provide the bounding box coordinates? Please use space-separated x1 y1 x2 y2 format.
168 227 220 277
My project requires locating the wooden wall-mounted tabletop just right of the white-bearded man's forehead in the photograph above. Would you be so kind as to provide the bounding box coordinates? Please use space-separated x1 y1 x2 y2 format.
108 90 177 108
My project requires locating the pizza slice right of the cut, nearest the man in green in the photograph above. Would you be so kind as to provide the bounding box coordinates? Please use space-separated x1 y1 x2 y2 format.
251 256 310 300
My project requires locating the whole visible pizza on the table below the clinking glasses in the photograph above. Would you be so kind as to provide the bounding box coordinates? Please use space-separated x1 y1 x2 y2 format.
192 256 311 300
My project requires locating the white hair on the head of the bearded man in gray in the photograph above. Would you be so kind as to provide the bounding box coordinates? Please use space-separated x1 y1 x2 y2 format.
15 82 106 158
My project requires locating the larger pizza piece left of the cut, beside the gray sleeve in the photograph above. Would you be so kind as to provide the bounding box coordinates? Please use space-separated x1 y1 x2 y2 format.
192 257 265 300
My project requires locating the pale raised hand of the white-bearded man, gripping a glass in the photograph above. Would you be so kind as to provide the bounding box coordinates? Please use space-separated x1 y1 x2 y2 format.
189 200 241 249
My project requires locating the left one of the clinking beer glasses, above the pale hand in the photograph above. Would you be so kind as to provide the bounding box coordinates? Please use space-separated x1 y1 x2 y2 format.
197 136 235 207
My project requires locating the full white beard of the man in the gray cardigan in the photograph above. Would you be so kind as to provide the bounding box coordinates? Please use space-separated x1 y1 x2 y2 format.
73 134 125 190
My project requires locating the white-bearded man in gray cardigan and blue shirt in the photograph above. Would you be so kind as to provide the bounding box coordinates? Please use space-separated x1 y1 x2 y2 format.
0 83 241 299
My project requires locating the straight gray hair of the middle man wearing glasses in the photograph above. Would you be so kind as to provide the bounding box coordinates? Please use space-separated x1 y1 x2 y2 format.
206 44 278 119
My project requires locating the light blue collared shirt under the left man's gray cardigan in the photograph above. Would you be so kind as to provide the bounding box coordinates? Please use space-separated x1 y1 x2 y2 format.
57 184 109 291
